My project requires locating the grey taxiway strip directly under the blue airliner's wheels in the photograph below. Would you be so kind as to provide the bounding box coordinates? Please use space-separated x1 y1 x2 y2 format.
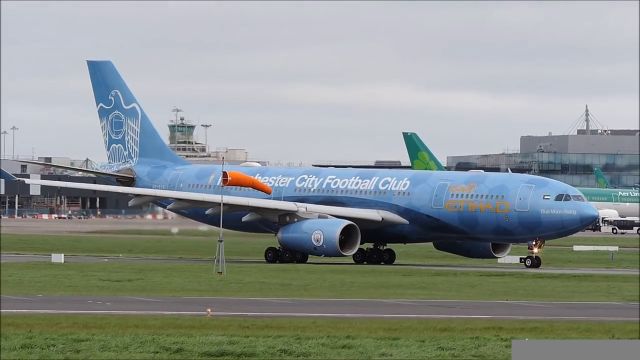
0 253 640 276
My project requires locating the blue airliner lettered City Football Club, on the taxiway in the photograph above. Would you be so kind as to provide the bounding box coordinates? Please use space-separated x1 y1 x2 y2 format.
11 60 598 268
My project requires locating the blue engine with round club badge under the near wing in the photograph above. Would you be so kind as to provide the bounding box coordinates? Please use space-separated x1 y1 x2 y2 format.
277 219 360 257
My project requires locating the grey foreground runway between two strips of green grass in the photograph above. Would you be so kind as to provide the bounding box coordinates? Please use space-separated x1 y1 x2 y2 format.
1 295 640 321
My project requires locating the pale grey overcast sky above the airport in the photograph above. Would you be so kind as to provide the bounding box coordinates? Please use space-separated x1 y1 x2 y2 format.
0 1 639 163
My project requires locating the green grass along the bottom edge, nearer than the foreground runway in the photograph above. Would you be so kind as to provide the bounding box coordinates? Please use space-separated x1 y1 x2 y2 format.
0 315 640 359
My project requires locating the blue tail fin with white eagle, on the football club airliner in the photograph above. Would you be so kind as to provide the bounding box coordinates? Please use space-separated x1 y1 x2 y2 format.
87 60 187 171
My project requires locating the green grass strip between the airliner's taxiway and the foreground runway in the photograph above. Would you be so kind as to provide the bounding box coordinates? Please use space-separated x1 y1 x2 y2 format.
0 262 639 302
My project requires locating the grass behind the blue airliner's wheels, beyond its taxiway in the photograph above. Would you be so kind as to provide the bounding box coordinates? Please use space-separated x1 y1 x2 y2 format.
0 230 640 269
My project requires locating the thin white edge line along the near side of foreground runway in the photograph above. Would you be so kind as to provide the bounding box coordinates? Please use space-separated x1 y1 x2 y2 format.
0 309 638 321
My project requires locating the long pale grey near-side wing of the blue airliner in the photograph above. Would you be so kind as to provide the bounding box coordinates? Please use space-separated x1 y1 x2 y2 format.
21 179 409 224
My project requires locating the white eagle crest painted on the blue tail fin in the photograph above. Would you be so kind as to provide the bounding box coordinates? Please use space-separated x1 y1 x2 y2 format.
98 90 141 169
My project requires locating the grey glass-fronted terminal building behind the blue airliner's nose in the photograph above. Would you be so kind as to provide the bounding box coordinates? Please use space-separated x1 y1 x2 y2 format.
447 108 640 188
